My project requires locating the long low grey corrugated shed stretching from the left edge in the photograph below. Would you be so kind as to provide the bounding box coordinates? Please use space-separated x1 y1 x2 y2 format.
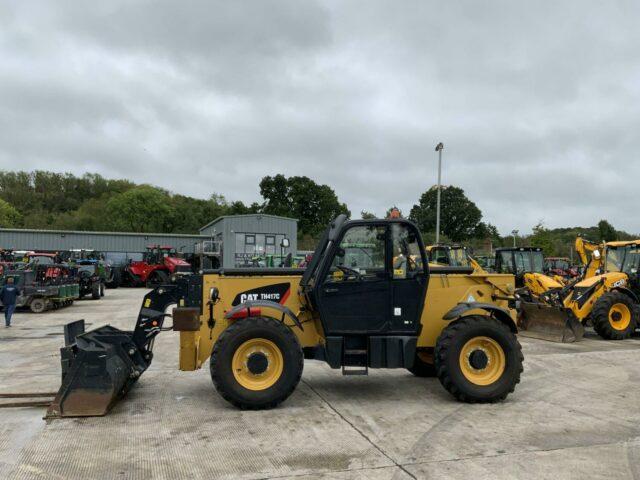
0 228 211 253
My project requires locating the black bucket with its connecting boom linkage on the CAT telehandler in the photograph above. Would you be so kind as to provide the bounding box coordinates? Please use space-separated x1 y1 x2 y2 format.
46 277 195 418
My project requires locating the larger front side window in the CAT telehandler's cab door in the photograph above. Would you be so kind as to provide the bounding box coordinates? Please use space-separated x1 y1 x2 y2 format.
325 225 386 282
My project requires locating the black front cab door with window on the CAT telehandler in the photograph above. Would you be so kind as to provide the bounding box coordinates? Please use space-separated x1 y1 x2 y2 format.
316 224 391 335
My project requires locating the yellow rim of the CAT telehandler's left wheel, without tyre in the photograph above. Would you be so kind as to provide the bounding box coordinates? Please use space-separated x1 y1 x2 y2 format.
231 338 284 390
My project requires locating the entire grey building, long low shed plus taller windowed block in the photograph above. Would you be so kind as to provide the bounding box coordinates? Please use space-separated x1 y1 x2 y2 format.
0 214 297 268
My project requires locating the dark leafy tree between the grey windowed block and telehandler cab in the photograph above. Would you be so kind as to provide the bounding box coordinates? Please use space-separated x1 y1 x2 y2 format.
260 175 351 236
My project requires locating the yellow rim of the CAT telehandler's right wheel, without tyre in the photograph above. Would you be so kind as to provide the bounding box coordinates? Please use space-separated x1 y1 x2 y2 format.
460 337 507 386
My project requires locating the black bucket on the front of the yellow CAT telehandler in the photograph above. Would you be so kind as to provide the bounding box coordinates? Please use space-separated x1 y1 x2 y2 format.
46 320 151 418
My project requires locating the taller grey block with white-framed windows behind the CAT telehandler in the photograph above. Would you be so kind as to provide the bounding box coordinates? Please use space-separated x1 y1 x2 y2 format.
200 214 298 268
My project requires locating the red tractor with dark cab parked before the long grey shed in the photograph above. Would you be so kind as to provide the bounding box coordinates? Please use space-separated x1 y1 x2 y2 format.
125 245 191 288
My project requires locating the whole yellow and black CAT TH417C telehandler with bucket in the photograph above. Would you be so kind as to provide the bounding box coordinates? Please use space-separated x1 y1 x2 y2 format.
48 215 523 417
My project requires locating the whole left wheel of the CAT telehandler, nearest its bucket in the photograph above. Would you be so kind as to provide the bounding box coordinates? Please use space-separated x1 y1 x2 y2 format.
210 317 304 410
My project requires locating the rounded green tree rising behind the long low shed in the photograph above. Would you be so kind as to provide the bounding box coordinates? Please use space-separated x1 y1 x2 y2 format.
105 185 176 233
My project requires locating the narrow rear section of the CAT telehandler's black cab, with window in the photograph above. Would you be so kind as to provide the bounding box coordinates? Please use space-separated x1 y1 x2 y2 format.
390 223 429 335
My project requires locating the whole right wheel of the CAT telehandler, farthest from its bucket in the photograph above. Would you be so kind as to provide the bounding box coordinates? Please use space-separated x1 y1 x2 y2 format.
435 315 524 403
